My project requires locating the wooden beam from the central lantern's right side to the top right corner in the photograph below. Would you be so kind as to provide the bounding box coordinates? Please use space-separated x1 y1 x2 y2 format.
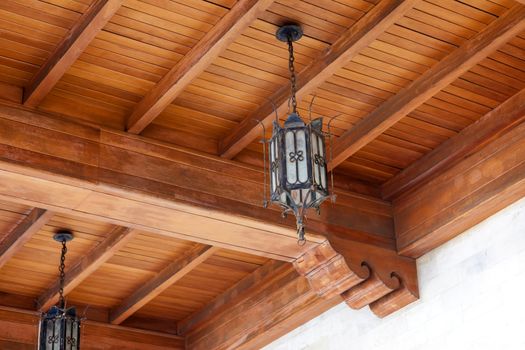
329 5 525 169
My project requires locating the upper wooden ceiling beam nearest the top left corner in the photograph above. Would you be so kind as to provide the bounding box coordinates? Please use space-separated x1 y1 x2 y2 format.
24 0 123 107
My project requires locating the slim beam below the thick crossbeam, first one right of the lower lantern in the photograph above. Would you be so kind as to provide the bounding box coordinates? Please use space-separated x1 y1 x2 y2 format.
110 244 218 324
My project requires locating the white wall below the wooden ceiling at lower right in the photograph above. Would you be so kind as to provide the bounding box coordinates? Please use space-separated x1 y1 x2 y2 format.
265 199 525 350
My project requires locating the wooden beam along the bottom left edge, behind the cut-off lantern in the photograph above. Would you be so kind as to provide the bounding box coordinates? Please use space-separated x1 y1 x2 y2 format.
0 306 185 350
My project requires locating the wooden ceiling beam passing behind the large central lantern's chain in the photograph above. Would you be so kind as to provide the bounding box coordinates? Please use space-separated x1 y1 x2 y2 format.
219 0 417 159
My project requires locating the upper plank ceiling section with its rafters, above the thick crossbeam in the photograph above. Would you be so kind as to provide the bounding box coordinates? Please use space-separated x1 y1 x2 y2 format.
0 0 525 189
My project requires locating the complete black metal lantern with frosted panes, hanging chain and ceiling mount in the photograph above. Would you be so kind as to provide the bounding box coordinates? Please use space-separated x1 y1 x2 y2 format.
268 25 329 244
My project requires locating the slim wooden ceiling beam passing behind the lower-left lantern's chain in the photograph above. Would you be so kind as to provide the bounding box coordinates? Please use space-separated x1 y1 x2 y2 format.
37 227 135 311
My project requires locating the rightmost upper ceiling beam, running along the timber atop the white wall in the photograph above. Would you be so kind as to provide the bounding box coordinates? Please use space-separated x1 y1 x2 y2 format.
382 90 525 199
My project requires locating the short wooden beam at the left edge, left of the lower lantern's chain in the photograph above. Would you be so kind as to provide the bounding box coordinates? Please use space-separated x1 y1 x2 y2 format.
0 208 53 268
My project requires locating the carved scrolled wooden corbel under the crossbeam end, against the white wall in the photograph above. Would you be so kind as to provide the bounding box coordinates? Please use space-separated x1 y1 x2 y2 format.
294 239 419 318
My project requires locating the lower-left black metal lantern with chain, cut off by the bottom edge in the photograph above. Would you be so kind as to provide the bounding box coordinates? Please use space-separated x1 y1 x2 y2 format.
38 231 80 350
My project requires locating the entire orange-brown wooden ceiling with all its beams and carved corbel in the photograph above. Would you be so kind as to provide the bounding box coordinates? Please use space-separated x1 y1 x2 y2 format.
0 0 525 349
